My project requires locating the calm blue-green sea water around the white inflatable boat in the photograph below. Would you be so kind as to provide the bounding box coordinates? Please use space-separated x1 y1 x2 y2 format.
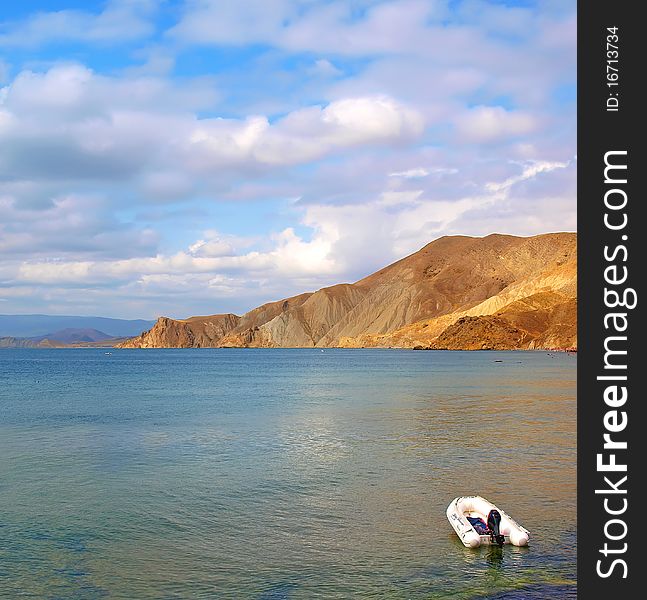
0 349 576 600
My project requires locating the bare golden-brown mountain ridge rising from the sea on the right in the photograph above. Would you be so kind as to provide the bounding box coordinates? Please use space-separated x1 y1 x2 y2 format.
120 233 577 349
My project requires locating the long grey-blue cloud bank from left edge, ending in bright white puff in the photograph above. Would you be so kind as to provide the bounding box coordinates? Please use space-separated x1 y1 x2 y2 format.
0 65 424 183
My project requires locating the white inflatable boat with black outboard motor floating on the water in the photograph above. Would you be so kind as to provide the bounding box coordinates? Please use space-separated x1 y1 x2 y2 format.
447 496 530 548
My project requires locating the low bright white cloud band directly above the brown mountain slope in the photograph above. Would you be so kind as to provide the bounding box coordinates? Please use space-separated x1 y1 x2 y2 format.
5 161 574 296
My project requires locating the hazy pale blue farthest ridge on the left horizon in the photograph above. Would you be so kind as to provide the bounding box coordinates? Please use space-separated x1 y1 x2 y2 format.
0 315 155 339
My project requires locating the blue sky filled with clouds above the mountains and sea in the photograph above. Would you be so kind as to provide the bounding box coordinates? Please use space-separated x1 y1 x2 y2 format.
0 0 576 318
